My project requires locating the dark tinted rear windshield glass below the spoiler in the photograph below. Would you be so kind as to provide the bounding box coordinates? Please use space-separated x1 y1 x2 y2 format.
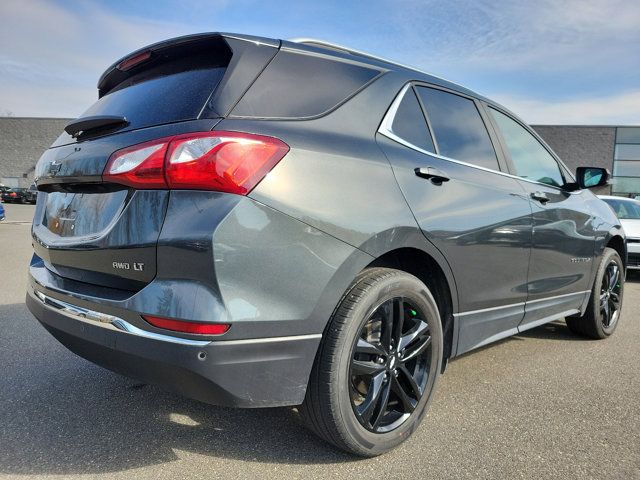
81 67 226 132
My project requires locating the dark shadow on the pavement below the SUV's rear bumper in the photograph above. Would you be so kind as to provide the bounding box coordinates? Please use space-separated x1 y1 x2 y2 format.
0 304 355 475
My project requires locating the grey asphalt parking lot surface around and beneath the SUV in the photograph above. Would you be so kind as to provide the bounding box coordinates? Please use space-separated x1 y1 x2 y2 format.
0 201 640 479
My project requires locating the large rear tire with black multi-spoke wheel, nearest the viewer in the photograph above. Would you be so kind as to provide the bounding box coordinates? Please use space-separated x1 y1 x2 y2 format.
300 268 442 457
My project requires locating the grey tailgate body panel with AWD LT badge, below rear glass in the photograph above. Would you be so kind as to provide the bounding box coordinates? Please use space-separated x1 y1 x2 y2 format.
32 119 219 291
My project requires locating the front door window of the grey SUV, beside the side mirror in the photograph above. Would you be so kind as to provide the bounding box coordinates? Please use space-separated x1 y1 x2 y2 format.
490 109 564 187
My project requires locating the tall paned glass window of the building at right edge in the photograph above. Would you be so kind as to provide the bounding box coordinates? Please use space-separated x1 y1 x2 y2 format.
611 127 640 196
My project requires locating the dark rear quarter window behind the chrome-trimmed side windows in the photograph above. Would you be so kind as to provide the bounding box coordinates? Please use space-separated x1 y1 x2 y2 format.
232 50 380 118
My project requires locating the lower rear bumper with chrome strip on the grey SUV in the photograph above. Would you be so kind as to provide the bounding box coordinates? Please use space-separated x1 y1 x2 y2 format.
26 288 321 407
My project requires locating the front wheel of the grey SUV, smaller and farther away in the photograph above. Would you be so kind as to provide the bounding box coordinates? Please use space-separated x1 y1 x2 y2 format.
566 248 624 339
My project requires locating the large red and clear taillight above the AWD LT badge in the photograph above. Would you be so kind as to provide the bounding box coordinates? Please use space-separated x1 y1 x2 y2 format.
103 131 289 195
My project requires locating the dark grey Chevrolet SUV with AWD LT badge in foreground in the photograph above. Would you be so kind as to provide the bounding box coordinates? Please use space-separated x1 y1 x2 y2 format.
26 33 626 456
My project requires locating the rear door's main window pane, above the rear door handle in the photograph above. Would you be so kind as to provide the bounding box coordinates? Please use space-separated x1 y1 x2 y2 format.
418 87 499 170
